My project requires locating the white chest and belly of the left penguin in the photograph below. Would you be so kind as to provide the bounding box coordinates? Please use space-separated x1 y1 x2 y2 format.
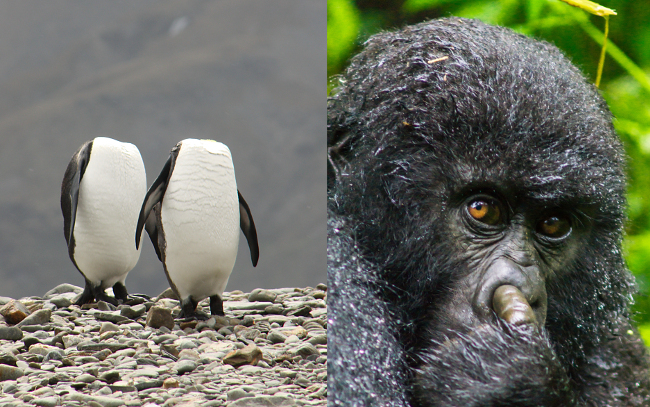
74 138 147 281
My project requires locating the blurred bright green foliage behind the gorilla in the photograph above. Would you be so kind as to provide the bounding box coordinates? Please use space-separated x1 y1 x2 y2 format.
327 0 650 345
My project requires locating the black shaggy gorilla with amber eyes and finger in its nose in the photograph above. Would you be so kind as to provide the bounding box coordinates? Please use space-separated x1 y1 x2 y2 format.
328 18 650 407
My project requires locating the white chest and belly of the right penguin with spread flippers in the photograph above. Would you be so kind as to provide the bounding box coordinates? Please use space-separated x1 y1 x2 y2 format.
161 141 239 298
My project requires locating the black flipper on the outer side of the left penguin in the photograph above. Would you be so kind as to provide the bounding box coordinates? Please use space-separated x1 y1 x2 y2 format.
61 140 93 258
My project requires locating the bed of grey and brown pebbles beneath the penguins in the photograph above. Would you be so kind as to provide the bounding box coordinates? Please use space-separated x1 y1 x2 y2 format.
0 284 327 407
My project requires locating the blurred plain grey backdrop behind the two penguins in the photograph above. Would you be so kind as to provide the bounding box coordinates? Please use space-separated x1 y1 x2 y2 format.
0 0 327 298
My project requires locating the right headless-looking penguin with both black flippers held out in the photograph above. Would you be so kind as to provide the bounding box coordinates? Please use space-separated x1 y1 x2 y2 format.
135 139 259 319
